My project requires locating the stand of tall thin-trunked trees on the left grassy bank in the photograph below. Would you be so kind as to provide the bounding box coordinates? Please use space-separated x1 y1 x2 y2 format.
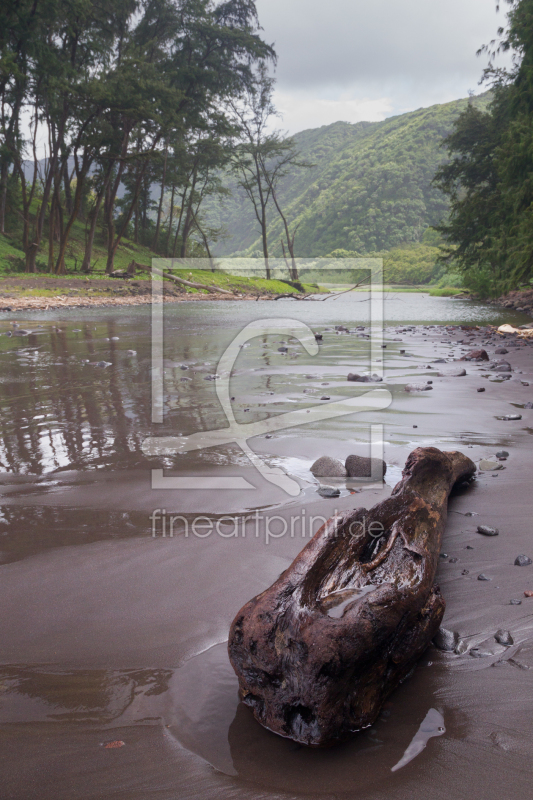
0 0 274 273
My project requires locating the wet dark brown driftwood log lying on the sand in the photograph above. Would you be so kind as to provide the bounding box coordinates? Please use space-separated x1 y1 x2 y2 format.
229 447 476 745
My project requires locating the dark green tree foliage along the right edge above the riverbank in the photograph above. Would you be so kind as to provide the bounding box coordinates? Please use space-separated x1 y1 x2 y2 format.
436 0 533 295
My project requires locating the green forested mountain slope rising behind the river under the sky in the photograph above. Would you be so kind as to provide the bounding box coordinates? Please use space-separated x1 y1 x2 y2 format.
208 93 490 257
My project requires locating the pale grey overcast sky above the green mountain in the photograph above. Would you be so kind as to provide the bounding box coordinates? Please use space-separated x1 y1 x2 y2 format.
256 0 505 133
